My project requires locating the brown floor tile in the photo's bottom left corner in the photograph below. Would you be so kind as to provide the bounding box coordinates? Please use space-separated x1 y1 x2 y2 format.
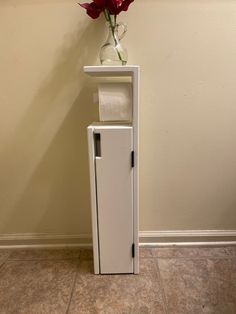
0 260 78 314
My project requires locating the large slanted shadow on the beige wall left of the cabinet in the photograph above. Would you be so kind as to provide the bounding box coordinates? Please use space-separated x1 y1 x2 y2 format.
0 21 104 233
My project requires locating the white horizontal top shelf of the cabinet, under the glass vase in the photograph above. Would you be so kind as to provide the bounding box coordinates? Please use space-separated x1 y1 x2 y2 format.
84 65 139 77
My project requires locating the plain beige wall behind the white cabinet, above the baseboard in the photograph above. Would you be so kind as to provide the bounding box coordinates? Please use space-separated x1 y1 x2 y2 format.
0 0 236 234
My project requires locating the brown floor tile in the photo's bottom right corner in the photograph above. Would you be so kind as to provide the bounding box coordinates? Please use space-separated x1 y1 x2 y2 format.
156 258 236 314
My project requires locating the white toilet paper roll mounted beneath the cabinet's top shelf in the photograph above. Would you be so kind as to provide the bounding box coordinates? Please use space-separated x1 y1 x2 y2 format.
98 83 132 121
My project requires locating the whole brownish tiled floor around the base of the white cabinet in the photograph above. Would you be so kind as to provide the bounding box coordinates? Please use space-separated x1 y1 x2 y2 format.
0 246 236 314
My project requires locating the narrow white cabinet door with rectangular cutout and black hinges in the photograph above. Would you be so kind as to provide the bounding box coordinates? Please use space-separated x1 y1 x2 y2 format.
95 126 133 274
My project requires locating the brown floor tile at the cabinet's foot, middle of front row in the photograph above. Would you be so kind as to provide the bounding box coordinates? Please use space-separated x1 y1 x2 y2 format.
69 259 165 314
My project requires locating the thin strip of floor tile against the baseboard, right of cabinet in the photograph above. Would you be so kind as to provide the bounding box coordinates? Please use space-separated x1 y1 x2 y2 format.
152 247 236 258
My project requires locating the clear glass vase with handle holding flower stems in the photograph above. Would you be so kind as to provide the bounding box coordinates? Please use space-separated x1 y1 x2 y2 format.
100 15 128 65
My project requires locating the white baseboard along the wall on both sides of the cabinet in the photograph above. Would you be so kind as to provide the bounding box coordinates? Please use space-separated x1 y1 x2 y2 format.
0 230 236 248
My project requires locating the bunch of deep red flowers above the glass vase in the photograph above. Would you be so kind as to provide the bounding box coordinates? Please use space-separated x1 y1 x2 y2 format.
79 0 134 19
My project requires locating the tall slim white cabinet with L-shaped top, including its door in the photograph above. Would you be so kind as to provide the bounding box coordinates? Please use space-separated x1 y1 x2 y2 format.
84 65 140 274
